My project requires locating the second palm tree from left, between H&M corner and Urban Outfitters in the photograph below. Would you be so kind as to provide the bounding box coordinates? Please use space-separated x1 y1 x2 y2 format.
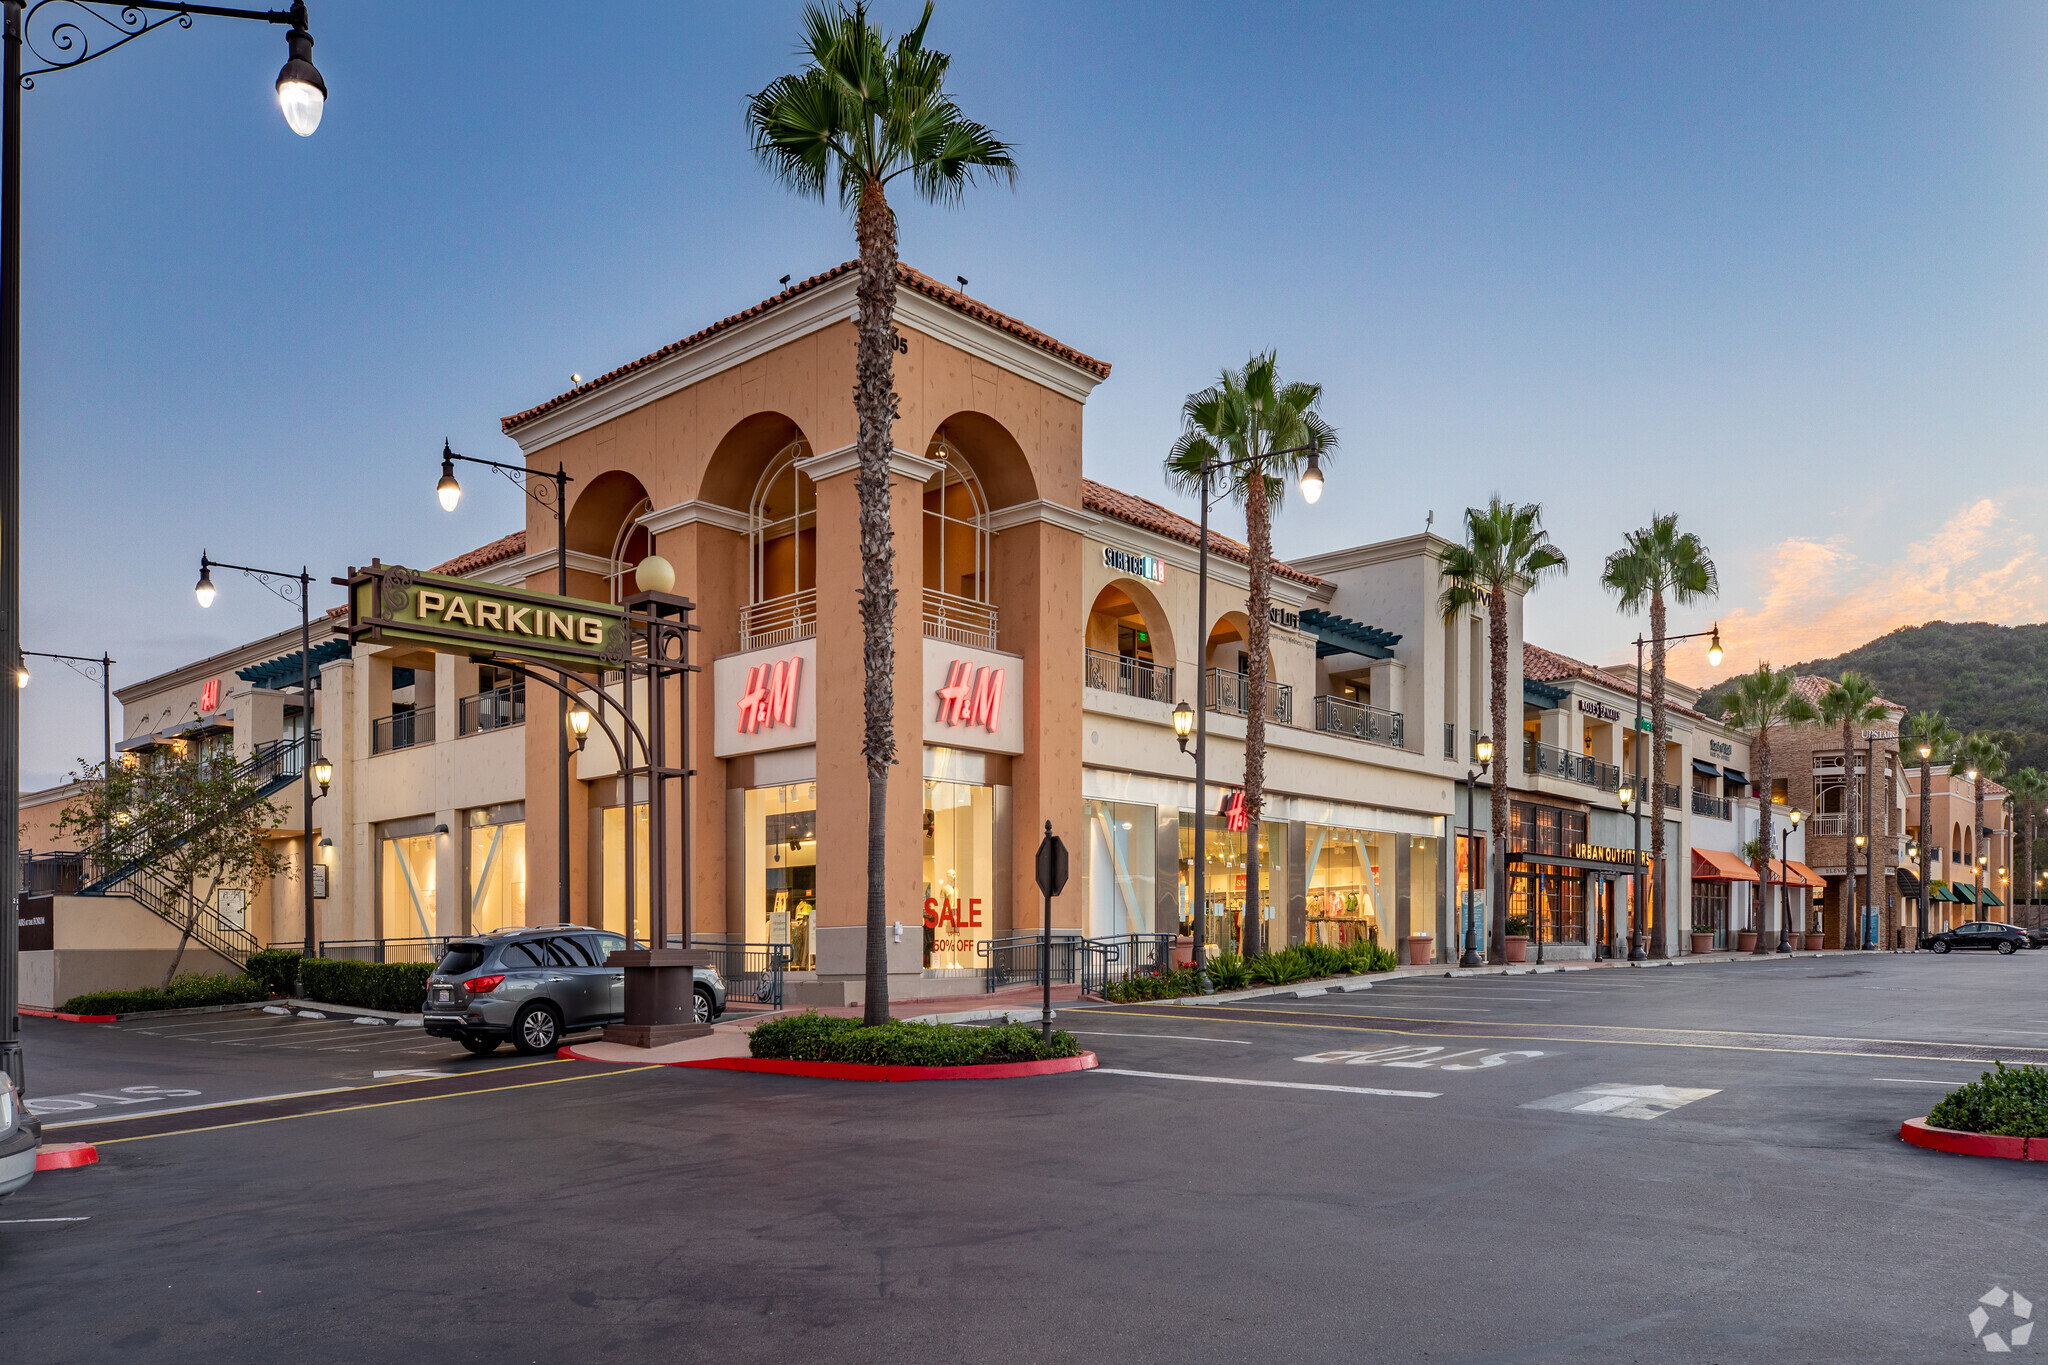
1165 350 1337 958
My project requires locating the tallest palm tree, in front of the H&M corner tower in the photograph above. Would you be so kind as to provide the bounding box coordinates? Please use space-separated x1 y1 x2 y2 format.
748 0 1016 1023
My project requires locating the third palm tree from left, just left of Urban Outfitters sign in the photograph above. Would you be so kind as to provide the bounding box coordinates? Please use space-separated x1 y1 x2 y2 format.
1438 493 1571 962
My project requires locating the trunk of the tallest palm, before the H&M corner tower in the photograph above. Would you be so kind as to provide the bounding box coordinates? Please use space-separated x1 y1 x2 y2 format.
854 180 897 1025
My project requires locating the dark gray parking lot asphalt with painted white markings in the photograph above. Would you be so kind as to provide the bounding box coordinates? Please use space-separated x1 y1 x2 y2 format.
0 954 2048 1363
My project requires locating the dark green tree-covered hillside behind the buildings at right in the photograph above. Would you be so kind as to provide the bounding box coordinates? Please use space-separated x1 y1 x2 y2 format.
1700 620 2048 769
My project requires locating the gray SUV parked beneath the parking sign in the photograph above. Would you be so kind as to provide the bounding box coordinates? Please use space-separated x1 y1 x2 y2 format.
422 925 725 1056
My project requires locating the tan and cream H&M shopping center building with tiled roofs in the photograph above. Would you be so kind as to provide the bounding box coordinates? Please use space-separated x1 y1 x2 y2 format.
24 264 1800 1003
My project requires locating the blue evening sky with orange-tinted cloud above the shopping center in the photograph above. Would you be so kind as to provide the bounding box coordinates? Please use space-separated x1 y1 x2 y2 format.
8 0 2048 786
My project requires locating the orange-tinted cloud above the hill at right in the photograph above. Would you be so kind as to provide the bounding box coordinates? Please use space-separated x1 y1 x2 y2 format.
1671 497 2048 686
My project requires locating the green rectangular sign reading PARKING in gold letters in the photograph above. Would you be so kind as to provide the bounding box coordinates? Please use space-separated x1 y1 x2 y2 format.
344 561 627 669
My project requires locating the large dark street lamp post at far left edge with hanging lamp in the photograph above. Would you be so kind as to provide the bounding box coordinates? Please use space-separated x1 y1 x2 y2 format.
0 0 328 1089
